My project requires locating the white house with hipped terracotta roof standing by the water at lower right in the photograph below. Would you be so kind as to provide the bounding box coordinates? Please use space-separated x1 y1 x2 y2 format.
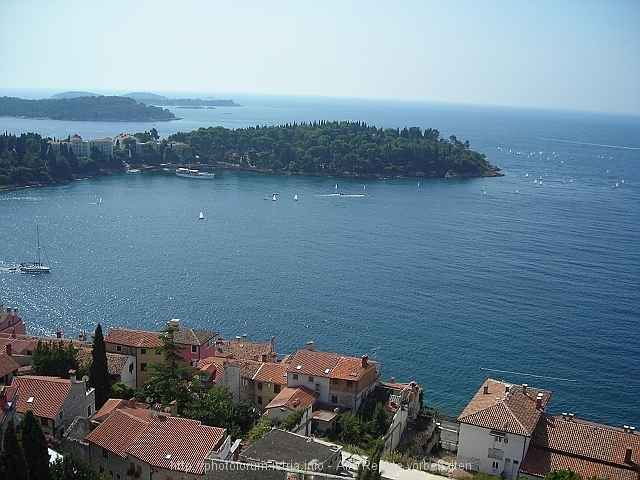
457 379 551 477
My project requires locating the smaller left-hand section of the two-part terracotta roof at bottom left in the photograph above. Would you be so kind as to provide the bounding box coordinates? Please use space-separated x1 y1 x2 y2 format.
86 410 150 458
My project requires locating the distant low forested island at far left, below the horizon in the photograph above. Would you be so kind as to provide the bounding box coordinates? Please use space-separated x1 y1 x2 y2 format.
0 96 177 122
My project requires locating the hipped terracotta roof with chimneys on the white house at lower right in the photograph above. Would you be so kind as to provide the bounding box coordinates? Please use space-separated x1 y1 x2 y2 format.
458 379 551 437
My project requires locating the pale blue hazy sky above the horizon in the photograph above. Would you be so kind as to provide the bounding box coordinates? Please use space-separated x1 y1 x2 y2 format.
0 0 640 115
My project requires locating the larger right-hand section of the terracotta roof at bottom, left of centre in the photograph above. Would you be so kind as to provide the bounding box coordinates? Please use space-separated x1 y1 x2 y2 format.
127 415 227 475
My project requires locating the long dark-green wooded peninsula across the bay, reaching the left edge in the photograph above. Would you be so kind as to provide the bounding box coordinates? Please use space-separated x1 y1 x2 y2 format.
0 121 502 187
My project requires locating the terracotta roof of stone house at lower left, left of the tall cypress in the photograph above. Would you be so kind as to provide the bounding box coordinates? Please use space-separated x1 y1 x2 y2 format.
11 376 79 419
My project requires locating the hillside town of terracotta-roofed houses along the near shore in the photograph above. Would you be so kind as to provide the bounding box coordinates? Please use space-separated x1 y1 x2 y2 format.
0 302 640 480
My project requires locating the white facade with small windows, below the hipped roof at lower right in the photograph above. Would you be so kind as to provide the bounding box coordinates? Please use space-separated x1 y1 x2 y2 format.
456 423 531 477
